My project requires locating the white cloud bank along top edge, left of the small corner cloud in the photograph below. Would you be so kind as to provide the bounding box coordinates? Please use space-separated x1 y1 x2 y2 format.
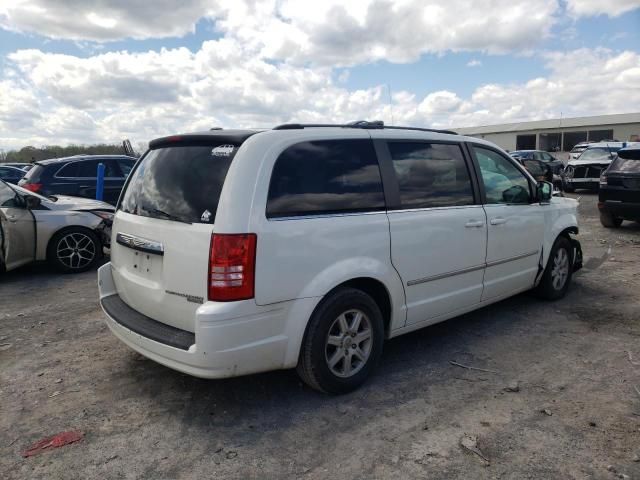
0 0 560 66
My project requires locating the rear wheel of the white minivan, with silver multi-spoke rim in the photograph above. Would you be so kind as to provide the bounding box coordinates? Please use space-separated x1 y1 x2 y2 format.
297 288 384 394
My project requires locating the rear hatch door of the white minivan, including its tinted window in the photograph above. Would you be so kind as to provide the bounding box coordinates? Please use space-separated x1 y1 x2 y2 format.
111 133 250 332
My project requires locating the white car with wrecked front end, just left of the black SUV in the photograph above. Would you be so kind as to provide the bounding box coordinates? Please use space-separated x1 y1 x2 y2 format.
562 142 625 192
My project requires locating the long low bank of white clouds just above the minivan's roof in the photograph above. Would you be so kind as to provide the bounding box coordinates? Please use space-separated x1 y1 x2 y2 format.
0 39 640 148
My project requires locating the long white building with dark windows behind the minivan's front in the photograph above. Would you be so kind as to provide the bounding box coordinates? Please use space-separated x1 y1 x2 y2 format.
453 112 640 152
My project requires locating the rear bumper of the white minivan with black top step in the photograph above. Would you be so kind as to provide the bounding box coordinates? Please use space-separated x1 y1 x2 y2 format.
98 263 315 378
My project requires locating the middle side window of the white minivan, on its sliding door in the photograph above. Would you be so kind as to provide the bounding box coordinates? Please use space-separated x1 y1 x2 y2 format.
388 142 474 208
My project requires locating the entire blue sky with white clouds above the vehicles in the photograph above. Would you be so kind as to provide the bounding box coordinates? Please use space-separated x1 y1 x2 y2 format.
0 0 640 148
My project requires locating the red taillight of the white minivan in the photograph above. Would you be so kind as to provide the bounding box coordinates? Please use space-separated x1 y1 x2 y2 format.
208 233 257 302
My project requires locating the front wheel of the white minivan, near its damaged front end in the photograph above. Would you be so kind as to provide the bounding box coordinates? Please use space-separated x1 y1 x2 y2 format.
536 236 573 300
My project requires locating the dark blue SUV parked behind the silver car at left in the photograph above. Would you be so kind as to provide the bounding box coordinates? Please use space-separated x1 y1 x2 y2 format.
19 155 136 204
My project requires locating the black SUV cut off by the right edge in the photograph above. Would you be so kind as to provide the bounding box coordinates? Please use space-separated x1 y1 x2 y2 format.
598 146 640 228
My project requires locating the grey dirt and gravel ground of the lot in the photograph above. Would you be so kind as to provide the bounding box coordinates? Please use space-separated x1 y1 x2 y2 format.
0 194 640 479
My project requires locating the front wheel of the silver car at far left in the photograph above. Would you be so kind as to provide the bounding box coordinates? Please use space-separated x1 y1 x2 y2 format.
47 227 102 273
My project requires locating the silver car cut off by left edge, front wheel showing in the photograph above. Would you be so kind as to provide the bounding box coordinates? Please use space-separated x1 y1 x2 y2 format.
0 181 114 272
